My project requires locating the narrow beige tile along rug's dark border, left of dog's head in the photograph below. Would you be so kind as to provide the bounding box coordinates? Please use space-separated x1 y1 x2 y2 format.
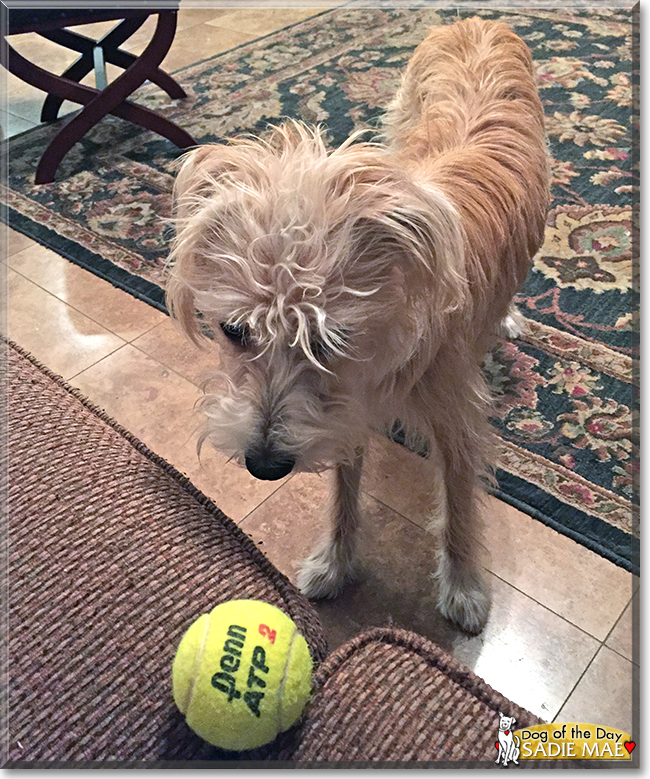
8 243 167 341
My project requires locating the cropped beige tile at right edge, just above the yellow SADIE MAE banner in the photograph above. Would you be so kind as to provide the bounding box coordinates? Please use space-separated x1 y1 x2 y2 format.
555 646 639 740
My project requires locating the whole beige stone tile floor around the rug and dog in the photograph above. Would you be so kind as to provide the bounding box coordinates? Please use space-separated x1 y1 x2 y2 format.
0 2 639 735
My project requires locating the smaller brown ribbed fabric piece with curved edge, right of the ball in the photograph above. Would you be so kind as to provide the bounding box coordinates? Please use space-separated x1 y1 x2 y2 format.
281 628 540 766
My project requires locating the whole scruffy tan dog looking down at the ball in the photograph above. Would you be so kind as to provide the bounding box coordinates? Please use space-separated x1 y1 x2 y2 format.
168 18 549 632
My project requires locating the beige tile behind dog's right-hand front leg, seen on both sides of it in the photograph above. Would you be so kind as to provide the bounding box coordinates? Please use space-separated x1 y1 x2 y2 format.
362 437 632 641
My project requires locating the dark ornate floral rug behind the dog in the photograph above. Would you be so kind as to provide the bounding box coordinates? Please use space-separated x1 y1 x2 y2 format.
3 8 639 572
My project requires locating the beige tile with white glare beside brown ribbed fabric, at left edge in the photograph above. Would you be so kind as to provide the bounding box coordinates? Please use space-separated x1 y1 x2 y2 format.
7 268 124 378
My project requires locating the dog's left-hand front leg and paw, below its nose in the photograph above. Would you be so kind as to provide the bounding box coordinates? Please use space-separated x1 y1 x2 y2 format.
298 452 363 598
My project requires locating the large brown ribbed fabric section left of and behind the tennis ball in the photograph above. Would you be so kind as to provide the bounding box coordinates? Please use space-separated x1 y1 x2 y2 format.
0 342 325 765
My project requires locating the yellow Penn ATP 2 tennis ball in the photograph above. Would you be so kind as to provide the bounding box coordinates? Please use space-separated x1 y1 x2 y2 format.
172 600 312 750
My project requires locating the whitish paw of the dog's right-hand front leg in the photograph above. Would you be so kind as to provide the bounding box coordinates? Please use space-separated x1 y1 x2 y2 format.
436 570 490 635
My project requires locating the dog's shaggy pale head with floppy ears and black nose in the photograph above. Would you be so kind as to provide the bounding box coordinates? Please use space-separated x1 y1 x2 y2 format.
167 123 465 479
